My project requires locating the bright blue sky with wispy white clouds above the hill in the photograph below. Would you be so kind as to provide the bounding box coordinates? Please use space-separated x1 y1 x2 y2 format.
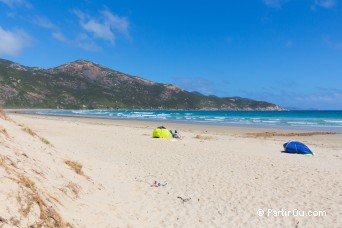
0 0 342 109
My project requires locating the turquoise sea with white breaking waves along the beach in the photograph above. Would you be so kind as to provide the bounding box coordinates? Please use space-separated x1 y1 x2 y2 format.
35 110 342 132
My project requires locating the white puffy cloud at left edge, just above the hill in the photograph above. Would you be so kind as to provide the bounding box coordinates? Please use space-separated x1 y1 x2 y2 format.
0 27 31 56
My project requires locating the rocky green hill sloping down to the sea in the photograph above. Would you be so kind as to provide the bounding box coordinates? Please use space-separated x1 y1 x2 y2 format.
0 59 282 110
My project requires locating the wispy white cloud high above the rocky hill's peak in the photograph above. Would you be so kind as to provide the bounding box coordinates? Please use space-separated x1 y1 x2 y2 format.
73 9 129 45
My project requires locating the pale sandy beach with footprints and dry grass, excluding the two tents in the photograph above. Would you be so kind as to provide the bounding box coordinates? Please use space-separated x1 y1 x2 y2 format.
0 113 342 227
